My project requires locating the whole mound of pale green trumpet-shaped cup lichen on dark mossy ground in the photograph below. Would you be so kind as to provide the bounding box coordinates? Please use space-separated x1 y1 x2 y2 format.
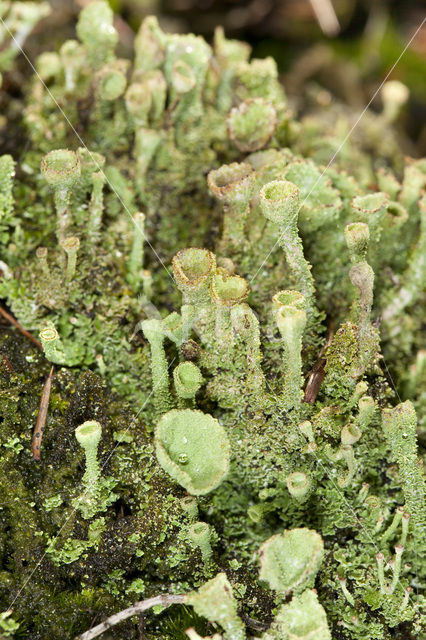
0 2 426 640
